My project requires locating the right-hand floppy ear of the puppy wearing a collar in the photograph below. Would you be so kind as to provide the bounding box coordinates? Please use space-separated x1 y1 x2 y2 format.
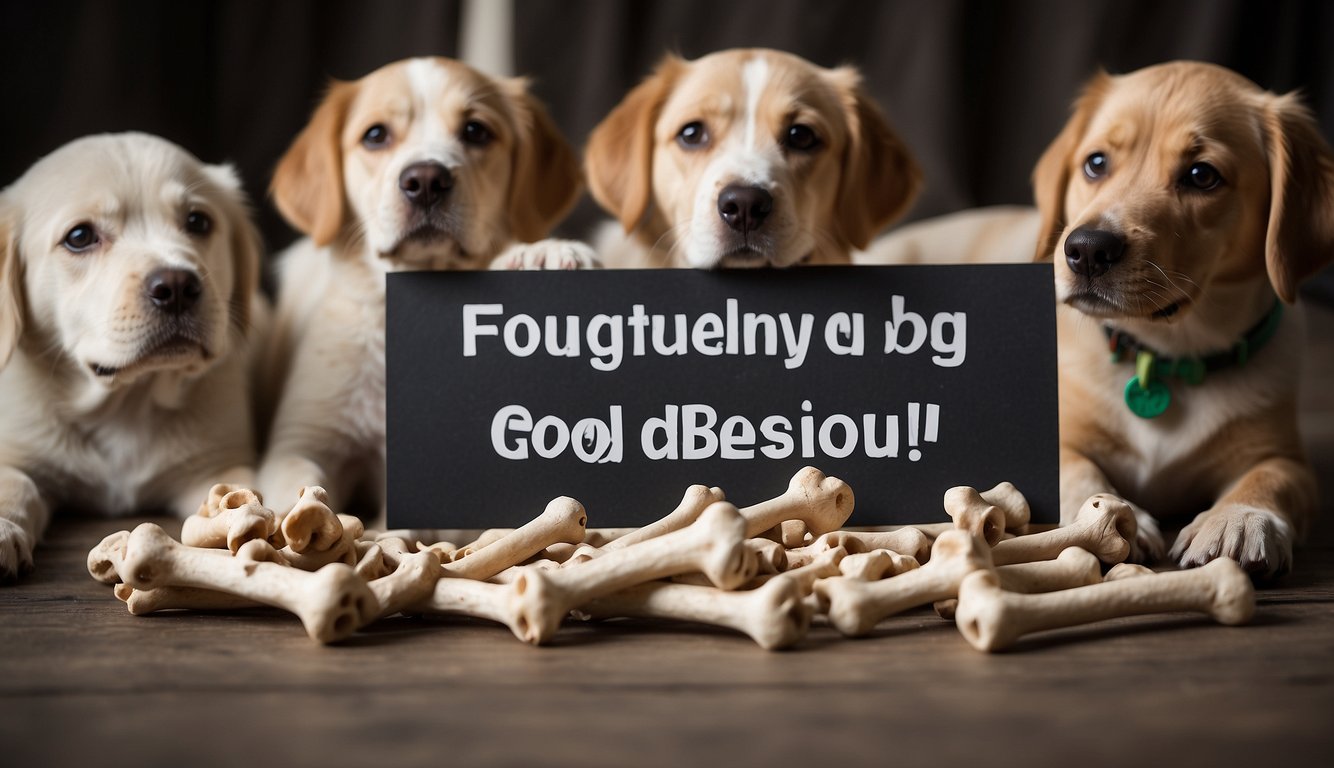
1265 93 1334 303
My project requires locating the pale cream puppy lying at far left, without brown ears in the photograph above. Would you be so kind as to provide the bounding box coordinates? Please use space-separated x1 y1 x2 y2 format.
0 133 260 577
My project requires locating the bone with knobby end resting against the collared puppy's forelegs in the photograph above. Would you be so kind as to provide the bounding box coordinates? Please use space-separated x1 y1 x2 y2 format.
991 493 1135 565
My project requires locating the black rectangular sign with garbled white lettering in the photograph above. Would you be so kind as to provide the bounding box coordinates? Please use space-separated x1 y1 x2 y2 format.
387 264 1059 528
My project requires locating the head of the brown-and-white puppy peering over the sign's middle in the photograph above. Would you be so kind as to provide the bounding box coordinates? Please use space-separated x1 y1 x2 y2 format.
584 49 922 268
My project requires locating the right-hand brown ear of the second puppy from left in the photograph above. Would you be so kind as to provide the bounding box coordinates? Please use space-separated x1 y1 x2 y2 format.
506 77 583 243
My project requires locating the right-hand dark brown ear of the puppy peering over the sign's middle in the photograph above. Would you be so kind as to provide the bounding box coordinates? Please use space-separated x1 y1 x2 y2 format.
830 67 922 251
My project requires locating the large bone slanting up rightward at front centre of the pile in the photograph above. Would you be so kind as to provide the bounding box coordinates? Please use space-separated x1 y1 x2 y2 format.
508 501 759 645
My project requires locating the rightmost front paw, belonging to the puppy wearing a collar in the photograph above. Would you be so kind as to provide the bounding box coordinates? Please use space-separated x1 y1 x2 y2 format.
1171 507 1293 576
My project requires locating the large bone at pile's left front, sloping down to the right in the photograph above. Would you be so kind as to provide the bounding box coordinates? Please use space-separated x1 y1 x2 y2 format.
117 523 380 643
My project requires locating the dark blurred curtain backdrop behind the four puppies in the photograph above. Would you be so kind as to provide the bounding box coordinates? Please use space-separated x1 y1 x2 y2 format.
0 0 1334 301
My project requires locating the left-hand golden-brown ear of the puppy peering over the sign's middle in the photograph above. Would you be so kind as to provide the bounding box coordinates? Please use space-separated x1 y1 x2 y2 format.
584 53 686 233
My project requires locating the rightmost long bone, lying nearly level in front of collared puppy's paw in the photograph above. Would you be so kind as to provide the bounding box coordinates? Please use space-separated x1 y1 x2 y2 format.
955 557 1255 651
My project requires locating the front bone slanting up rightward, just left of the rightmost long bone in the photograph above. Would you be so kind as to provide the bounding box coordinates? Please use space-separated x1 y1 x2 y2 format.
815 531 991 637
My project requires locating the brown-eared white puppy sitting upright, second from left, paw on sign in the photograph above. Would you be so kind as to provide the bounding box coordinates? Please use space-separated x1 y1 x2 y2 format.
260 59 588 511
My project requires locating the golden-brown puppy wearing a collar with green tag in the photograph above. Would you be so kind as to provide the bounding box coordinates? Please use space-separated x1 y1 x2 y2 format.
1034 61 1334 575
